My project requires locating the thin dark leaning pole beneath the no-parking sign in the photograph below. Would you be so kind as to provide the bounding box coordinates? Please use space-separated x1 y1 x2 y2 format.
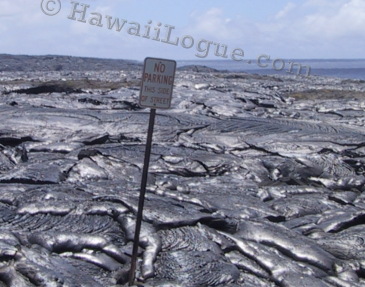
129 109 156 286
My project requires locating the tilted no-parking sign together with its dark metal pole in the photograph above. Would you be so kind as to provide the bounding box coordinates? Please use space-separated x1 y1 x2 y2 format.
129 58 176 286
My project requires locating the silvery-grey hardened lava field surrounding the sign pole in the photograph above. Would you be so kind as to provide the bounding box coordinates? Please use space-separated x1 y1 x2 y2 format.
0 56 365 287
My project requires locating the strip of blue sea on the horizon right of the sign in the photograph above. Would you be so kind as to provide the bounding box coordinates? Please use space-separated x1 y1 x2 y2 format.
177 59 365 80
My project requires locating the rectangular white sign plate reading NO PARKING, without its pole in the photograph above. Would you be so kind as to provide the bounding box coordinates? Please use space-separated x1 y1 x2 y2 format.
139 58 176 109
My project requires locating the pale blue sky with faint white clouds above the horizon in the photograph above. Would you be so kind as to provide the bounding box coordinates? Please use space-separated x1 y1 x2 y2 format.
0 0 365 60
